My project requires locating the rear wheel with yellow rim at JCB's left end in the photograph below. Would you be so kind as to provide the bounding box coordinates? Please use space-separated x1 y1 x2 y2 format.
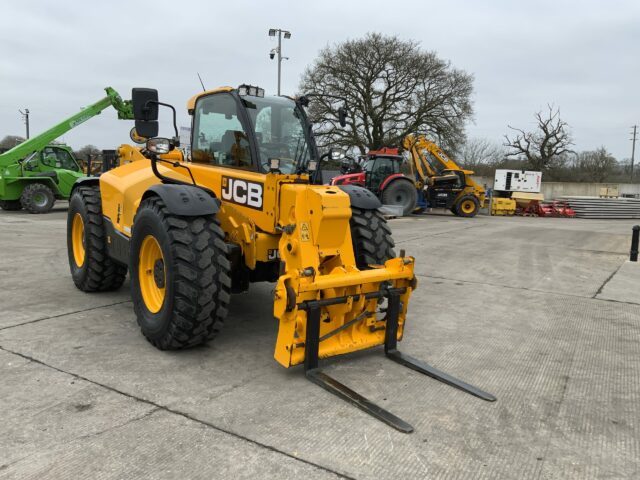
67 187 127 292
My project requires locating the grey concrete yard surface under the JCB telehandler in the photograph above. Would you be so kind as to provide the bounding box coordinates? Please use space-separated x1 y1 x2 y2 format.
0 206 640 479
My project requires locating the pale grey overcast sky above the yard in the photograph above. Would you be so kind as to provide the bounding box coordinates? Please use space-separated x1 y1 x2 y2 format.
0 0 640 159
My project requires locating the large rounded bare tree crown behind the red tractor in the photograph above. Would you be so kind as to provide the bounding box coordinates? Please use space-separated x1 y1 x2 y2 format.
299 33 473 153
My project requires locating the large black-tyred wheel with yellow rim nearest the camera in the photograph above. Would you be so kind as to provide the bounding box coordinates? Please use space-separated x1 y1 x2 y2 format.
129 197 231 350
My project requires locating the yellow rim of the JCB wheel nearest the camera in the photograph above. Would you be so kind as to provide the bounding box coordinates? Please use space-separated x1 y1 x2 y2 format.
138 235 166 313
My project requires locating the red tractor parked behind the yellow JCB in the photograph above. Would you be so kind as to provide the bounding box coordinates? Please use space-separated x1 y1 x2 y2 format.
331 148 418 215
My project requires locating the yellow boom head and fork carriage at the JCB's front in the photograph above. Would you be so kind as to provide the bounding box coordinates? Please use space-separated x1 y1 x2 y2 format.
274 184 415 367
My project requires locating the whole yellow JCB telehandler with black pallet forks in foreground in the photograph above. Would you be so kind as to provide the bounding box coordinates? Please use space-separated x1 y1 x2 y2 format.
67 85 495 433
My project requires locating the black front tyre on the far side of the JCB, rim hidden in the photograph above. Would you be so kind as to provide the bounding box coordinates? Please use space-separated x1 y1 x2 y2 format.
350 208 396 270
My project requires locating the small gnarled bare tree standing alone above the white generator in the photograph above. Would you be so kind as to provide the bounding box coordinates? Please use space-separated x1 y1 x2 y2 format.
504 105 573 170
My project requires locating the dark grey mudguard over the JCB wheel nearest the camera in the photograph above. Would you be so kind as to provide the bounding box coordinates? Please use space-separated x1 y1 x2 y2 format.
142 184 220 217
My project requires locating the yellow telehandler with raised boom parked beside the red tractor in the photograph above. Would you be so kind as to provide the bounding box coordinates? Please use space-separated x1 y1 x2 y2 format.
402 134 486 217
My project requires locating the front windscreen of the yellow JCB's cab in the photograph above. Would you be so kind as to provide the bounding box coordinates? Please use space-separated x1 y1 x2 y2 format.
242 97 312 174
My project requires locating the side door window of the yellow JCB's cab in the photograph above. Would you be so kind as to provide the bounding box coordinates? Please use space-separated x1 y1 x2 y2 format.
191 93 253 168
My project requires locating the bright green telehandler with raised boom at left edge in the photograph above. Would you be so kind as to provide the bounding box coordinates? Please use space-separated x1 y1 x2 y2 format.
0 87 133 213
